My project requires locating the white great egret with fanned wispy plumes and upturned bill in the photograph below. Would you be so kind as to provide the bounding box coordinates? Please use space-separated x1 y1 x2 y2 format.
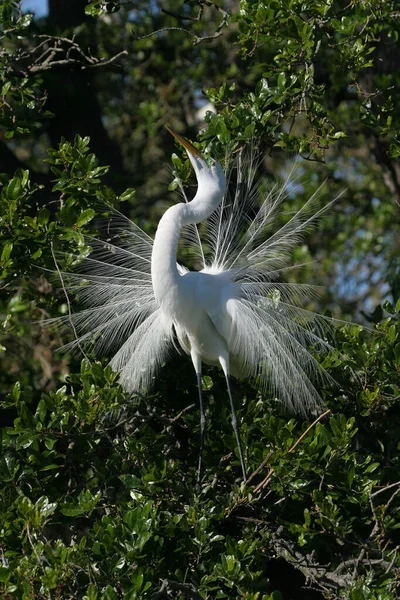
54 130 340 483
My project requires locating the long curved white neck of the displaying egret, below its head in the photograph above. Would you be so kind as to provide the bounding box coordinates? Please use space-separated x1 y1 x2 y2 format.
151 187 224 304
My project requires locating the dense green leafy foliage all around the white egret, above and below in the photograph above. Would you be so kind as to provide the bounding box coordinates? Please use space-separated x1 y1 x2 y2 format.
0 0 400 600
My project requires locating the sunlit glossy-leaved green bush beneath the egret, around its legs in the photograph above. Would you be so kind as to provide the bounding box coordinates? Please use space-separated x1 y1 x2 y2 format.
0 305 400 600
